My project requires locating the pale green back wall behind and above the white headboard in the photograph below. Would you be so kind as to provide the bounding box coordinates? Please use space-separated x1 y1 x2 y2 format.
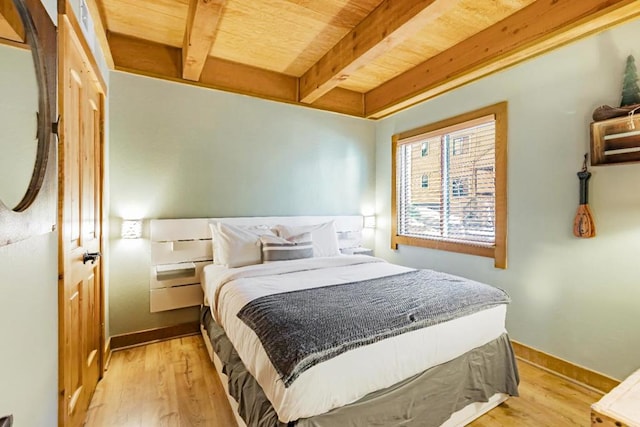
109 72 375 335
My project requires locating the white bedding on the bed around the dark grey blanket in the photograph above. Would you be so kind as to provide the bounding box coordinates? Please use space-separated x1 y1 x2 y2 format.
202 255 506 423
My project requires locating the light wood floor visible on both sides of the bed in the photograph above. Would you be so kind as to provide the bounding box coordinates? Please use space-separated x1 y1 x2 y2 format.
85 335 601 427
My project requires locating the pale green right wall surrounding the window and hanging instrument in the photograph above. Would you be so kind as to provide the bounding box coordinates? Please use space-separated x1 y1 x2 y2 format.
376 21 640 378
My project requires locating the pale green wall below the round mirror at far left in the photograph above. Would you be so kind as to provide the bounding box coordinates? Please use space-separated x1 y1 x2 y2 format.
0 0 58 427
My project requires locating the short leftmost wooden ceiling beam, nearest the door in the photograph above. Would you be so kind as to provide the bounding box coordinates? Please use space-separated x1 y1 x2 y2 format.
182 0 227 82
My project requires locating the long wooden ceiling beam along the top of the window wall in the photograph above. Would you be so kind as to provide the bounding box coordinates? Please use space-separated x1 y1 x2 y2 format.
365 0 640 118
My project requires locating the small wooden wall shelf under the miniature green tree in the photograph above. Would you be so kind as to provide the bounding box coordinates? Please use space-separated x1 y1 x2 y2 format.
591 113 640 166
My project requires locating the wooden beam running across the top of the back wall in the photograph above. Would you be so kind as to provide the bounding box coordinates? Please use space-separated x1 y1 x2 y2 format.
108 33 364 117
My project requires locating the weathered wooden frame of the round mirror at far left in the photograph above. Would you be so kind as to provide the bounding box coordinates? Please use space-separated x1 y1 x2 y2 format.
0 0 58 246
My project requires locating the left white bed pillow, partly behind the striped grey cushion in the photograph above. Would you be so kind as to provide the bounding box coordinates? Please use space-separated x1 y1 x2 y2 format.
209 222 274 268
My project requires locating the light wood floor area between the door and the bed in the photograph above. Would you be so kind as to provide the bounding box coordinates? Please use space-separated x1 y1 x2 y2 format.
85 336 236 427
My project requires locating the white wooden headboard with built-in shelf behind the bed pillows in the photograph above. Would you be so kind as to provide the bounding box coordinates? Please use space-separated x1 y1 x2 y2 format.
149 215 363 312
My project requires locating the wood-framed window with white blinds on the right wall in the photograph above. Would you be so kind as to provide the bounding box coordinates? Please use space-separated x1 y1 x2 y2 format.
391 102 507 268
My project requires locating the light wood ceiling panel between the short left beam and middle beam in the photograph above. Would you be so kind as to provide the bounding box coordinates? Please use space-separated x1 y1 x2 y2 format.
211 0 381 77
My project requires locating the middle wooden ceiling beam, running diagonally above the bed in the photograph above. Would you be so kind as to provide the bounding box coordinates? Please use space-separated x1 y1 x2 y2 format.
300 0 458 103
